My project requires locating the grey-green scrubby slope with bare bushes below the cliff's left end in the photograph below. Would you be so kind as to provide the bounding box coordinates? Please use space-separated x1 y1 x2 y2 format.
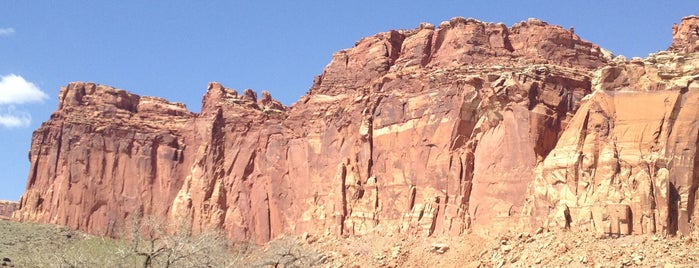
0 217 242 268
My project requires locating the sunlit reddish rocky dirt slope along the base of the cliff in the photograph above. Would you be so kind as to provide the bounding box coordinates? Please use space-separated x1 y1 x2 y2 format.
243 228 699 268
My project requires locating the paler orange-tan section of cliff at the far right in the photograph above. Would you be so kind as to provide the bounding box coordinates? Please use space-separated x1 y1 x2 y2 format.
529 49 699 234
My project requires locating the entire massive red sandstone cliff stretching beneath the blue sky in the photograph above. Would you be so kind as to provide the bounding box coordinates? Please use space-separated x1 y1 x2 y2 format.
15 18 699 243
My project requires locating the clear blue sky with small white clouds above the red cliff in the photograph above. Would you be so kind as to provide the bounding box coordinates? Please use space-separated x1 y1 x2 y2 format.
0 0 699 200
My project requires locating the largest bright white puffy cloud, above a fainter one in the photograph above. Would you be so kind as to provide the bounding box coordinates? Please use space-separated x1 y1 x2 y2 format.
0 74 49 105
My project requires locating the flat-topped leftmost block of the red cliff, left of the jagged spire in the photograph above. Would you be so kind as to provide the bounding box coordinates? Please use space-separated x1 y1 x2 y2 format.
15 83 195 234
